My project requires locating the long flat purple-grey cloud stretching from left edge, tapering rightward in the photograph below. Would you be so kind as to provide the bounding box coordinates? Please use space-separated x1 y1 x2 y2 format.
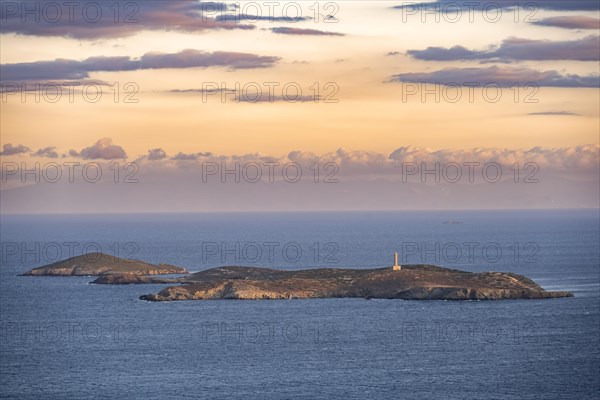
0 49 279 81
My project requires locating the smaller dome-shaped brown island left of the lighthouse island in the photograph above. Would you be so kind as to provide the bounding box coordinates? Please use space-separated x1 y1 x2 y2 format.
23 253 188 276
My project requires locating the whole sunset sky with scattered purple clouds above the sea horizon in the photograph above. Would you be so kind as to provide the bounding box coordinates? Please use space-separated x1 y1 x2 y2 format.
0 0 600 213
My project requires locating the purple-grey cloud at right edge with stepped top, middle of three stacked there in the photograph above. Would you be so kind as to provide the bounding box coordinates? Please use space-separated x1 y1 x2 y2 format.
407 36 600 61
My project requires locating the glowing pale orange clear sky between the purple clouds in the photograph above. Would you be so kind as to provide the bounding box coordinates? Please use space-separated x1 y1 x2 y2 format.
0 2 600 155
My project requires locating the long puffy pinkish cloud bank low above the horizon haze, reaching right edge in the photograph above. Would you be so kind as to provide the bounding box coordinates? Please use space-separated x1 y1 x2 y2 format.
136 144 600 179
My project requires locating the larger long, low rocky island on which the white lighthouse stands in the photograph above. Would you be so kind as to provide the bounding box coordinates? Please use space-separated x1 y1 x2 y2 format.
140 265 573 301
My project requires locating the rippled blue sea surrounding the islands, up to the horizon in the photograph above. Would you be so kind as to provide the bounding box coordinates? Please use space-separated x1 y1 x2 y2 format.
0 210 600 400
